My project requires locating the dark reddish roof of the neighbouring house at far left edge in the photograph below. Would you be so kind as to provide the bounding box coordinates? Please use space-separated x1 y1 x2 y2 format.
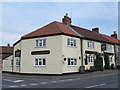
0 46 13 59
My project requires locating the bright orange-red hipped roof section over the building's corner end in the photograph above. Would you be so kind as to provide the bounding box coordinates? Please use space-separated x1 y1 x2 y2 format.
22 21 79 38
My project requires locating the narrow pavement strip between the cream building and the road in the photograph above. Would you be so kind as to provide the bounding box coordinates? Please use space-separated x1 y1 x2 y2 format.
2 69 118 80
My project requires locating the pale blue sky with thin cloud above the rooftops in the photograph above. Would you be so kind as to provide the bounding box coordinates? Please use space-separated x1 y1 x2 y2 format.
0 2 118 45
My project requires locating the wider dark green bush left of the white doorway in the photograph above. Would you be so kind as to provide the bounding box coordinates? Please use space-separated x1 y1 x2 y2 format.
94 53 103 71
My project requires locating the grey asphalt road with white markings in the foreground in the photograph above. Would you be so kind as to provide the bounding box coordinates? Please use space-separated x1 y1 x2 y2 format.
2 74 120 88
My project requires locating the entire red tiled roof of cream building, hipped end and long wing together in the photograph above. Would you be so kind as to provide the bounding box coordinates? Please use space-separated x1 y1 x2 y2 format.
22 21 119 43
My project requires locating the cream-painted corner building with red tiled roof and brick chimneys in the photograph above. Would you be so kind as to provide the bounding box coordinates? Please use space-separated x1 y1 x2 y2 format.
3 14 120 74
